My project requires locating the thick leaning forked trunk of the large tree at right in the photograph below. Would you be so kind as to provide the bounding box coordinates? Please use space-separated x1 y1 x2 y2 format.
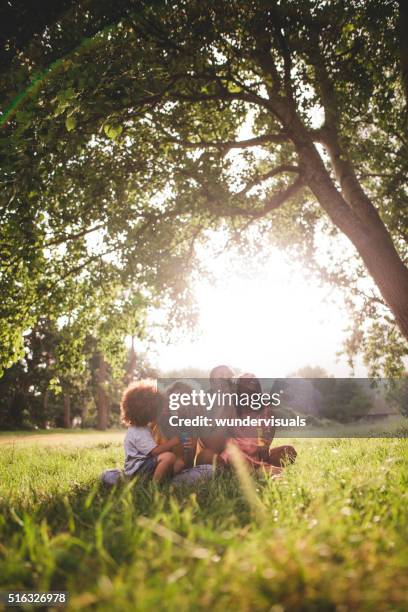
261 67 408 339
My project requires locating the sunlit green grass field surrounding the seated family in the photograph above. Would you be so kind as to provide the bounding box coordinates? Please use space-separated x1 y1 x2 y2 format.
0 432 408 612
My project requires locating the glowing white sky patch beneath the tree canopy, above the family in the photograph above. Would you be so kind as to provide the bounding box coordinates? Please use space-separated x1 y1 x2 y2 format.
140 239 366 378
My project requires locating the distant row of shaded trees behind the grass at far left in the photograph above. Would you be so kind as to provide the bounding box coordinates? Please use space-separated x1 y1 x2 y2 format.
0 317 157 430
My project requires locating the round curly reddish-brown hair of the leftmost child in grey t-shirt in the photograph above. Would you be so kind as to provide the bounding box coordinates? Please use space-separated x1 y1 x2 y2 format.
120 379 163 427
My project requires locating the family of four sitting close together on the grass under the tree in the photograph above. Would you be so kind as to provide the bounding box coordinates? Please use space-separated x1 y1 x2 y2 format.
121 366 296 483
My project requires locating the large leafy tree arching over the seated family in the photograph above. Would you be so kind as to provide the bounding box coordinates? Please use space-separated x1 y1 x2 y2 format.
0 0 408 376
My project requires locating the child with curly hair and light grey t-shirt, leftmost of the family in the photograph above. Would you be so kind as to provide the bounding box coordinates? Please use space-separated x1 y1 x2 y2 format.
120 380 184 483
